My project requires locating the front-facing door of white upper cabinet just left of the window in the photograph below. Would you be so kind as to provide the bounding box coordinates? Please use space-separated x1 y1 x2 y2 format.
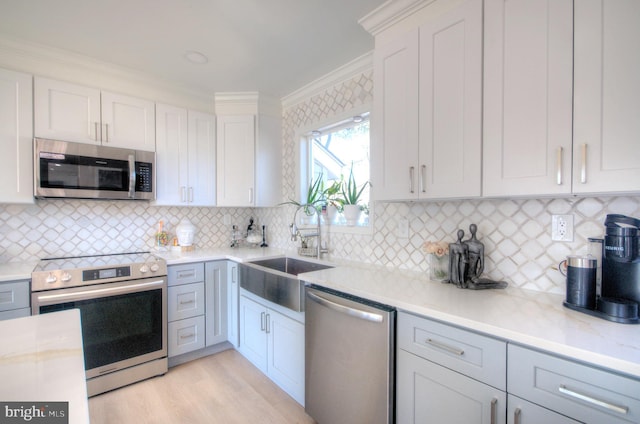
216 115 256 206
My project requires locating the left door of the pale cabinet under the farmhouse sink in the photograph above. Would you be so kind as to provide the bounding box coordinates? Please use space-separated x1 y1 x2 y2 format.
238 296 268 374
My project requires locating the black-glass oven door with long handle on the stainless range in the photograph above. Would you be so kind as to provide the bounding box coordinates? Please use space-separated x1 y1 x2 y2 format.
31 277 167 379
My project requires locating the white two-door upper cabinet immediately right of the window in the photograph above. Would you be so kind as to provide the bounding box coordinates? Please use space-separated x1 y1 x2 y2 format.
363 0 482 200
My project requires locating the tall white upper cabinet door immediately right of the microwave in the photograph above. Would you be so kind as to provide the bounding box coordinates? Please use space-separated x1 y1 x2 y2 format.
156 104 189 205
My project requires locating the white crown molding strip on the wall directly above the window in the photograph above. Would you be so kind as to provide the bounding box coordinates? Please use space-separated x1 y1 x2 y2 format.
282 51 373 109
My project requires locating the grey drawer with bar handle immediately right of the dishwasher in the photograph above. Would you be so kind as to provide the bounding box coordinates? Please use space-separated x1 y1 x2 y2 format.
398 312 507 390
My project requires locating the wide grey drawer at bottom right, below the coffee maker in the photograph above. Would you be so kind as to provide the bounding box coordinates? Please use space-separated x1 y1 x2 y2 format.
507 344 640 423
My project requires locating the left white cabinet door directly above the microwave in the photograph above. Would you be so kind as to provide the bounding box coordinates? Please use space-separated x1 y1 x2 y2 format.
33 77 101 144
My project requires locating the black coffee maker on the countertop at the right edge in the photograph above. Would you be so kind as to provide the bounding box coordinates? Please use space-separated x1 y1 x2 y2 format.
598 215 640 322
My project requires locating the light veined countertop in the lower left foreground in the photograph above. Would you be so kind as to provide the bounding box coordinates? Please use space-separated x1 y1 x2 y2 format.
0 309 89 424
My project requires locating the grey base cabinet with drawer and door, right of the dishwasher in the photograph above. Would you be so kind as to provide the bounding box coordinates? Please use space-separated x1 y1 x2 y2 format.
396 312 507 424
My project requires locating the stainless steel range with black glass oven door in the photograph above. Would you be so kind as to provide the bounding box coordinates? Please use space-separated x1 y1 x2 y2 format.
31 252 168 396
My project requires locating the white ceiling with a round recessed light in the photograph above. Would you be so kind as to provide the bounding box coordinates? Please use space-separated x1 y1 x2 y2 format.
0 0 384 97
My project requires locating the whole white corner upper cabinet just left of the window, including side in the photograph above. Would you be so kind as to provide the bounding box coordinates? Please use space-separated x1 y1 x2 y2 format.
216 92 282 207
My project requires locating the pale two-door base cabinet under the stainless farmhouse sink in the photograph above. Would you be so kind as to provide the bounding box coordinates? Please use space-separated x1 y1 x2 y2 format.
238 290 304 405
